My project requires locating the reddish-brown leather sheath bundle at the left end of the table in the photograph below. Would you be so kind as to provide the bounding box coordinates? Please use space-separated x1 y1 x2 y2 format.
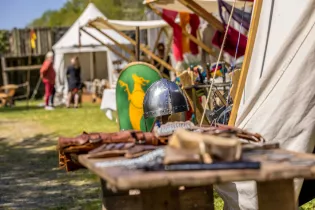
57 130 165 171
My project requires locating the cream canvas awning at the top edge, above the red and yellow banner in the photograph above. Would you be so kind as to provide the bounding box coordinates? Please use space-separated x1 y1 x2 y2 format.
143 0 253 13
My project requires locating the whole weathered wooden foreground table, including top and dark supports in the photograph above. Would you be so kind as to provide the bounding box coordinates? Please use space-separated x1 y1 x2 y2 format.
79 149 315 210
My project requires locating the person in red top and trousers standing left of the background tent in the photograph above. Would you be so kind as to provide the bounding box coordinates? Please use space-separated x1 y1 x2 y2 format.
40 51 56 110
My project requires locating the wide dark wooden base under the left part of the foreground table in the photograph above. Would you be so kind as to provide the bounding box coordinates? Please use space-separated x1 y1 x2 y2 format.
101 179 214 210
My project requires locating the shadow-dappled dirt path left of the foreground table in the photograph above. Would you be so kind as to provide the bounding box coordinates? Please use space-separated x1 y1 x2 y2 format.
0 119 100 210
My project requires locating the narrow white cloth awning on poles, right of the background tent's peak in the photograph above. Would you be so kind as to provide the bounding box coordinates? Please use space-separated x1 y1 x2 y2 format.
89 18 179 31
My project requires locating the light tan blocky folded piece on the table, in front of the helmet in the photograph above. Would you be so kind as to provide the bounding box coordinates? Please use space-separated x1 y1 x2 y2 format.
164 128 242 164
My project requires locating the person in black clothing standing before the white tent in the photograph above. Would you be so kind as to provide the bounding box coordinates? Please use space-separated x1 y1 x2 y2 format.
66 57 82 108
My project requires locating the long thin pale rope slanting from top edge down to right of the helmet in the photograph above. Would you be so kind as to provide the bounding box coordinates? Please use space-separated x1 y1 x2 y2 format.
199 0 236 126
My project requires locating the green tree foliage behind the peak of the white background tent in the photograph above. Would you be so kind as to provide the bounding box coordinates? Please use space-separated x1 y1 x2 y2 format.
29 0 144 27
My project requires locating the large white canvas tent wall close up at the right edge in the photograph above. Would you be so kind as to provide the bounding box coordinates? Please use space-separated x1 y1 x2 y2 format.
217 0 315 210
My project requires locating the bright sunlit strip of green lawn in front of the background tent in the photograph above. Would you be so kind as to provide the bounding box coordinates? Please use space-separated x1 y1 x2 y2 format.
0 101 315 210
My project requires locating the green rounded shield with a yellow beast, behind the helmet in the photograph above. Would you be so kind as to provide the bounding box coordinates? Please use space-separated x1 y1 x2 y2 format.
116 62 162 131
